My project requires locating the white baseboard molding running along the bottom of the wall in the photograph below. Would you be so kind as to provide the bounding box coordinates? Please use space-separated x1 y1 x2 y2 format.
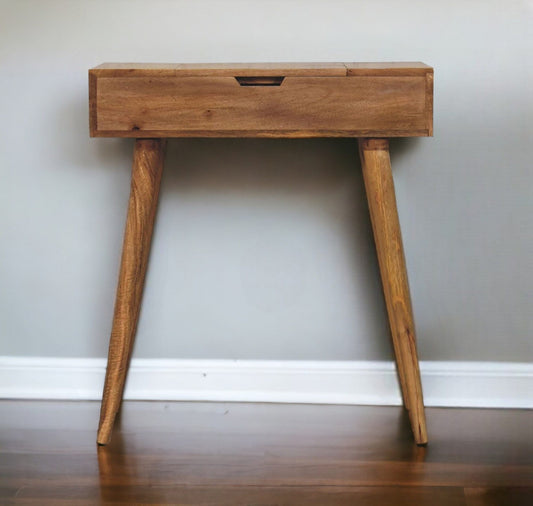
0 357 533 408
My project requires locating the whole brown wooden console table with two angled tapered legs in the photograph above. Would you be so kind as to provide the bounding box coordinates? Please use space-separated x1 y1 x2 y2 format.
89 63 433 445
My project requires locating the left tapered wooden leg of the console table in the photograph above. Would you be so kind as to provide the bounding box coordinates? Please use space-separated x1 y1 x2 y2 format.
97 139 165 445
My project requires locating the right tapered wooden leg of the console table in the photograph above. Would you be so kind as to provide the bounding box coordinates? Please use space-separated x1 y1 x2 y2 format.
359 139 427 445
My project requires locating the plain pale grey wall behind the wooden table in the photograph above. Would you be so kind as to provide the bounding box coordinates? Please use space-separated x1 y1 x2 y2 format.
0 0 533 362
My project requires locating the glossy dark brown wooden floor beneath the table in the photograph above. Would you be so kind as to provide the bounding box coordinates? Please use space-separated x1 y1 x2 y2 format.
0 401 533 506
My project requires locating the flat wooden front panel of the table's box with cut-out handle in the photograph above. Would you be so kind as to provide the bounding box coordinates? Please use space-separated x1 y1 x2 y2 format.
90 74 432 137
